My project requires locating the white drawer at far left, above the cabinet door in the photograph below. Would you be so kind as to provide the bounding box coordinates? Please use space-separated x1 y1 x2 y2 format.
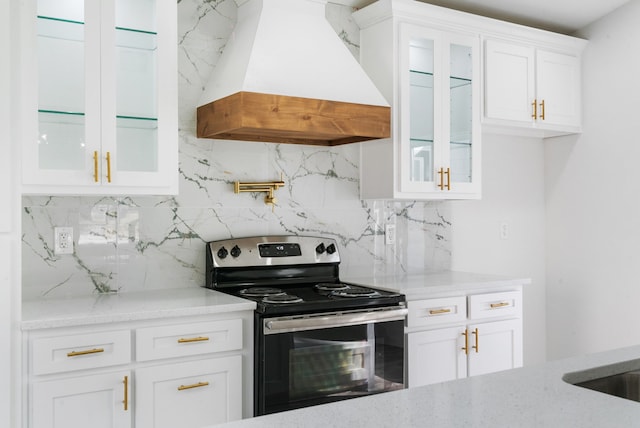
31 330 131 375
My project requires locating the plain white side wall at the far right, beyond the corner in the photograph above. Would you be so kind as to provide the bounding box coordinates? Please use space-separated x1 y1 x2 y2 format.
545 0 640 359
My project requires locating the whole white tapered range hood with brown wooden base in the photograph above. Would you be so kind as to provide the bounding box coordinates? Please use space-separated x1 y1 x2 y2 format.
197 0 391 146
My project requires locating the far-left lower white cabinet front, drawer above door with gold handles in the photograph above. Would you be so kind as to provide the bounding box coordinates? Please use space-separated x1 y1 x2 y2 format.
28 329 132 428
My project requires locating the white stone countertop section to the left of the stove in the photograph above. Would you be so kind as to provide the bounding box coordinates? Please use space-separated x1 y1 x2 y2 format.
22 287 256 330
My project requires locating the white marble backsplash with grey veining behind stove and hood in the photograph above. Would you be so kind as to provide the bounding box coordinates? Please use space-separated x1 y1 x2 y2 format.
22 0 451 299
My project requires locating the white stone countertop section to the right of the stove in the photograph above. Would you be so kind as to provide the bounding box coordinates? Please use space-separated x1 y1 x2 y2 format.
340 271 531 300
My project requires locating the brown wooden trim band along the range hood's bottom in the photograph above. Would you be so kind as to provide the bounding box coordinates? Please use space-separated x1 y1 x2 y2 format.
197 92 391 146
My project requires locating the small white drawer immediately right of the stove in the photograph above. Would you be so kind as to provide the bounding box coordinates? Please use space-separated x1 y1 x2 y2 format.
407 296 467 327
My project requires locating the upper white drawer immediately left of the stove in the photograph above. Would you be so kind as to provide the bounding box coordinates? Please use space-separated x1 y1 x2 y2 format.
136 319 242 361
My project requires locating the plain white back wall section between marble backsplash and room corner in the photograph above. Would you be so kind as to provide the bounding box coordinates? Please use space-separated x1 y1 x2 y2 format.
451 135 546 364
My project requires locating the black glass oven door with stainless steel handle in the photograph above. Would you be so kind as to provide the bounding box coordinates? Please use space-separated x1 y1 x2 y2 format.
254 307 407 415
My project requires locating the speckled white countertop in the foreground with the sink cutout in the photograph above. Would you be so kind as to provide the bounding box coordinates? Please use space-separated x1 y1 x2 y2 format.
216 346 640 428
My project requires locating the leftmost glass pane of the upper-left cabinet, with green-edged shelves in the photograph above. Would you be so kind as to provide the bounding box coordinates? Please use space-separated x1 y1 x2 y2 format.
36 0 99 178
